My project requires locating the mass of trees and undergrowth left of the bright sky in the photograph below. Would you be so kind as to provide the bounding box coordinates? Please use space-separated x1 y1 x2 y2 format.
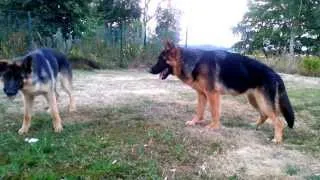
0 0 179 68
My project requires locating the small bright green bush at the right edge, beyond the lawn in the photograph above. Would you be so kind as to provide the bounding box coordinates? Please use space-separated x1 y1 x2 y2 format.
299 56 320 76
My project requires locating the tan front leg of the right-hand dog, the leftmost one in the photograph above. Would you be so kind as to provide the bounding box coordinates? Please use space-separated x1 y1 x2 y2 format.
186 91 207 126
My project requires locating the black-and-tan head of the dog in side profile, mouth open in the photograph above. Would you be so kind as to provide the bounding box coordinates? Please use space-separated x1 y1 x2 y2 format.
149 41 178 80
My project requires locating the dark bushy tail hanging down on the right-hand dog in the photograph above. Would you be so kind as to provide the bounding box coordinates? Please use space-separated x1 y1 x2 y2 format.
278 79 294 128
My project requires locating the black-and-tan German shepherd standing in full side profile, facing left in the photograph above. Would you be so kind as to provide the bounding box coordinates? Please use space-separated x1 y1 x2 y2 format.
150 42 294 143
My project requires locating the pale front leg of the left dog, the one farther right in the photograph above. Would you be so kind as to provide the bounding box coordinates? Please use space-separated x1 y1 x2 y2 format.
45 91 63 132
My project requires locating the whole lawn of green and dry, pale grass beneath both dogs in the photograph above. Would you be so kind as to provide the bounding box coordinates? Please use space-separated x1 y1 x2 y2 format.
0 71 320 179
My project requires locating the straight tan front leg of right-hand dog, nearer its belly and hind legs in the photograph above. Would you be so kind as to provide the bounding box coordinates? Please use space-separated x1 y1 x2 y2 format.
206 91 221 129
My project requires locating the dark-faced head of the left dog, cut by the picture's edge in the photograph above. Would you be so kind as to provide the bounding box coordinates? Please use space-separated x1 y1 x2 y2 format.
0 57 32 97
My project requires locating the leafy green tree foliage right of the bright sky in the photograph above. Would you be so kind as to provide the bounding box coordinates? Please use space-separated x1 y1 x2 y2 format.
233 0 320 54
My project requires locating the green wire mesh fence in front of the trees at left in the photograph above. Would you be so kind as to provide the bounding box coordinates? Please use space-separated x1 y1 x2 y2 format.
0 11 148 67
